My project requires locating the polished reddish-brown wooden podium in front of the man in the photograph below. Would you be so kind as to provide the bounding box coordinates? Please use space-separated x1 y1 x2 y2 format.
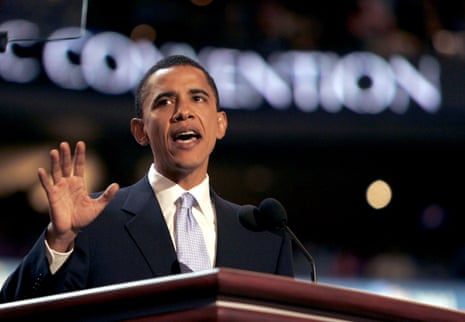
0 268 465 322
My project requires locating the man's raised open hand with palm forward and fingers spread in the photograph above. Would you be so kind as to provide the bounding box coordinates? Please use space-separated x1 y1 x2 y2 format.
38 141 119 252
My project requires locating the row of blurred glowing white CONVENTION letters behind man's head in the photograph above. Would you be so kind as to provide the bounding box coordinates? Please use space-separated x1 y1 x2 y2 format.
0 17 441 114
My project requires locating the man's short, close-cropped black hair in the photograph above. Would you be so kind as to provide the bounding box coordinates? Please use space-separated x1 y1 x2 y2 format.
135 55 220 118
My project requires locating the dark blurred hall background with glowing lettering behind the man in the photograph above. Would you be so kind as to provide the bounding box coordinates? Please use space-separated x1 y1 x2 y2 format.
0 0 465 309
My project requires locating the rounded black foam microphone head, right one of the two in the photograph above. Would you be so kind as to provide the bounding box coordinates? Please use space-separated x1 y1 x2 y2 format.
255 198 287 229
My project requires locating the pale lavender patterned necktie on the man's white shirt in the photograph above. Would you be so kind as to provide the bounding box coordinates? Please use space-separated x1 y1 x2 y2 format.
175 192 210 273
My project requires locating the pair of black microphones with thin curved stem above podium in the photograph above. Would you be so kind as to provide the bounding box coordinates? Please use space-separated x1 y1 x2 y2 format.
239 198 316 282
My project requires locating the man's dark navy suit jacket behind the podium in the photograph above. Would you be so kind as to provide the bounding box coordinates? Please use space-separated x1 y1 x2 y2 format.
1 177 294 302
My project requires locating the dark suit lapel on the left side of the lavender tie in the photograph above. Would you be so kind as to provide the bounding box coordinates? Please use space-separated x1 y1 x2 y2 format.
123 177 179 276
